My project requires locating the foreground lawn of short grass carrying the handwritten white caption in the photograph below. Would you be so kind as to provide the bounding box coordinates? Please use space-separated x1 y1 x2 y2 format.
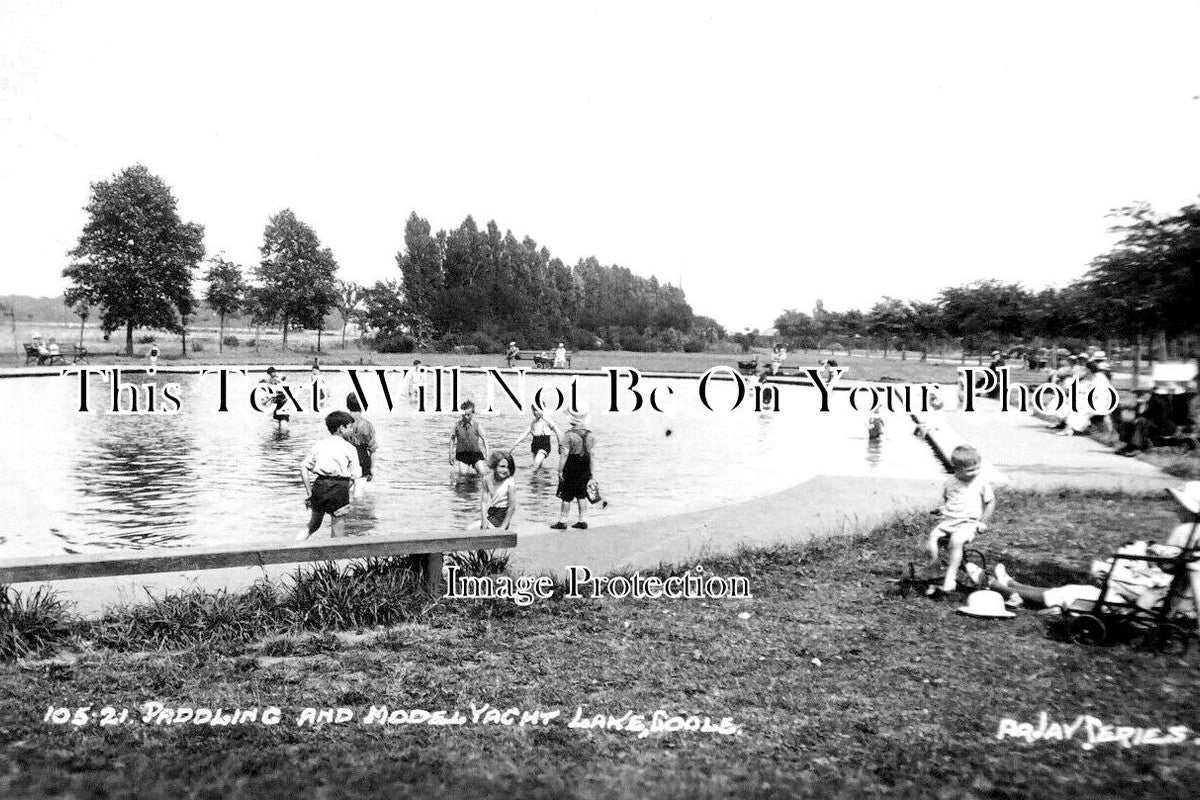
0 493 1200 798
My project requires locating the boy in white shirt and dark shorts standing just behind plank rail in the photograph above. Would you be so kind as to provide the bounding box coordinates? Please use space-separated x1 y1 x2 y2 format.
296 411 362 541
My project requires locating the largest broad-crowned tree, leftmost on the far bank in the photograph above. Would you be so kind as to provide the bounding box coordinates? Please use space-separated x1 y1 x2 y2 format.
62 164 204 355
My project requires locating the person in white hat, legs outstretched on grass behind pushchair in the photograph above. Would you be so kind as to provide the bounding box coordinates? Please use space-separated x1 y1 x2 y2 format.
995 481 1200 619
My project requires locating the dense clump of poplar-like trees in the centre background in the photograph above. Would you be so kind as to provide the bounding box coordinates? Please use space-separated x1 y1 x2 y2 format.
362 212 705 351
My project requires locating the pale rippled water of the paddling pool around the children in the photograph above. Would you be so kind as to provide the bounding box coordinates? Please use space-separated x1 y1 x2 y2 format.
0 372 942 558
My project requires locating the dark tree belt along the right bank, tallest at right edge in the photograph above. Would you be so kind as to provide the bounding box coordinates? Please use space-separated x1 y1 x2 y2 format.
768 205 1200 355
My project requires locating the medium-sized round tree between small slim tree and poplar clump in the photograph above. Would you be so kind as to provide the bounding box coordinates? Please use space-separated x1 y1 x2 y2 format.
254 209 337 350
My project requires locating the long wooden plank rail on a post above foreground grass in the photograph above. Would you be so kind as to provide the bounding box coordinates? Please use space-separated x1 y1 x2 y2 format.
0 530 517 595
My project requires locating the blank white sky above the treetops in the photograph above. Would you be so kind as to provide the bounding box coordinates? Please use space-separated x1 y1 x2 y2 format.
0 0 1200 330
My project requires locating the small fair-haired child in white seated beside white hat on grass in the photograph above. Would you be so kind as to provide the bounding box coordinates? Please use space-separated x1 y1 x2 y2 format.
926 445 996 596
